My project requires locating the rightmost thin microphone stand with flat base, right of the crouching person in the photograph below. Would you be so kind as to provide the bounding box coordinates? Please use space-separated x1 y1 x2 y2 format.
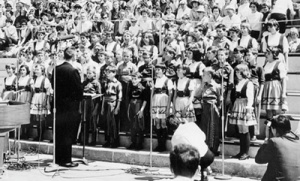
215 61 231 180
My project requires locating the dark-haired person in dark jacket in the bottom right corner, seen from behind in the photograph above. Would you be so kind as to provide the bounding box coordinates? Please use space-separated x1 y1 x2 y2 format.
255 115 300 181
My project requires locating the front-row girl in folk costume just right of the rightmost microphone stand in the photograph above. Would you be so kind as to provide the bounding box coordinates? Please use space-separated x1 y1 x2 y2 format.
229 64 257 160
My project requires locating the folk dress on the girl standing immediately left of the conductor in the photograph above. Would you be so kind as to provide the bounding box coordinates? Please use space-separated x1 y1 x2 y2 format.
30 75 51 115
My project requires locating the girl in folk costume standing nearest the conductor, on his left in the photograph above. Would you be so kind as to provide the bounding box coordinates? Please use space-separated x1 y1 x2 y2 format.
30 64 52 140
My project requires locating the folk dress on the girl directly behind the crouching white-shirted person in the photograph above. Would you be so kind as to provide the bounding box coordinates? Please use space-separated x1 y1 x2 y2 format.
174 77 196 122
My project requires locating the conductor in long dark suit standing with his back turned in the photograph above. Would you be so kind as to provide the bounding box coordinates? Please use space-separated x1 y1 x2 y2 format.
51 47 83 167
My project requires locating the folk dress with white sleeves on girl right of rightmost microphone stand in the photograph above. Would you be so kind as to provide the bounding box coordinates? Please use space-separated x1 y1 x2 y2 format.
229 79 257 134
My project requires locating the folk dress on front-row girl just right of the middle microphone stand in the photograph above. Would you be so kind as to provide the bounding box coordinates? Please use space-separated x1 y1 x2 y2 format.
152 75 174 124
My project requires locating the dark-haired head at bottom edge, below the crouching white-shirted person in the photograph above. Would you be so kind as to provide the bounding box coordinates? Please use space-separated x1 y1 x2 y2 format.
170 144 200 178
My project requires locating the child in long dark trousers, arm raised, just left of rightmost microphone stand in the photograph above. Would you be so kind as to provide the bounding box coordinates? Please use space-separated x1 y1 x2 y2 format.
195 67 222 154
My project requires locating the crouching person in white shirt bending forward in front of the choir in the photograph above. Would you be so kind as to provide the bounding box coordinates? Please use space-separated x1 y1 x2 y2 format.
169 118 214 181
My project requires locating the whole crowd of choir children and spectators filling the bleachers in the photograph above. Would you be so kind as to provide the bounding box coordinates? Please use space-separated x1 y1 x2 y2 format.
0 0 300 159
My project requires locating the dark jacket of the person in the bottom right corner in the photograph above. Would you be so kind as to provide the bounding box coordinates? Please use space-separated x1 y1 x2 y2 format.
255 135 300 181
